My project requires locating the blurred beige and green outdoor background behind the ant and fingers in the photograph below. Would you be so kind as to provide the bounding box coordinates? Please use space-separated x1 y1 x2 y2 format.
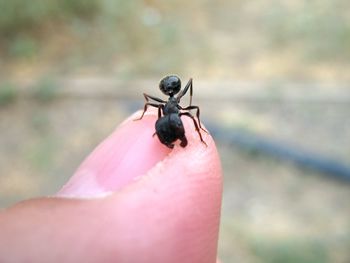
0 0 350 263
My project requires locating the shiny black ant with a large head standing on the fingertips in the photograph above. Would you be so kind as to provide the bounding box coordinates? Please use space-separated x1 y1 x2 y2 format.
136 75 207 149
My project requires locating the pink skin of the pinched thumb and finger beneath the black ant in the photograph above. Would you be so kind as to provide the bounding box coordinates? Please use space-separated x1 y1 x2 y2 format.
0 112 222 263
